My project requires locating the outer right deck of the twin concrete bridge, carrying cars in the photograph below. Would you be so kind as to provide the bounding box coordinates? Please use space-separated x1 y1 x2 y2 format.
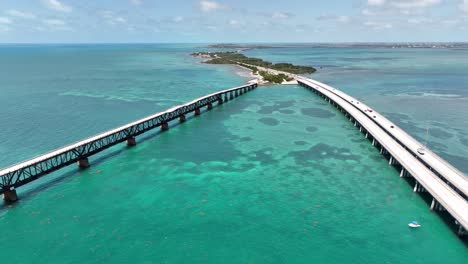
300 76 468 199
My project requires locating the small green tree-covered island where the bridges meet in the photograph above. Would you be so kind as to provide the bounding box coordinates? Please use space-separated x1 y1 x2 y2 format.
192 51 316 84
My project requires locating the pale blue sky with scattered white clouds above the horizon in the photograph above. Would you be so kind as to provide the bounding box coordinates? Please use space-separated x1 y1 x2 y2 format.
0 0 468 43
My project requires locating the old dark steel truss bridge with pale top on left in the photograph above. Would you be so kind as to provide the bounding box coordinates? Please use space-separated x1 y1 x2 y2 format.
0 83 257 202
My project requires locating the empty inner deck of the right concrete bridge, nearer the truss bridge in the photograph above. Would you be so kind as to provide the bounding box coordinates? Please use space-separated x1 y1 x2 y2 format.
299 78 468 230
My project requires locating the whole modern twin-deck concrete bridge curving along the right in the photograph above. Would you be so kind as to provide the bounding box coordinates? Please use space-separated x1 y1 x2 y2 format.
296 76 468 236
